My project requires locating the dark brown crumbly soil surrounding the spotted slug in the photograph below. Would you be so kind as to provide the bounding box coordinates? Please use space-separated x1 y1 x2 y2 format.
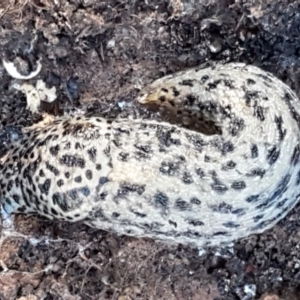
0 0 300 300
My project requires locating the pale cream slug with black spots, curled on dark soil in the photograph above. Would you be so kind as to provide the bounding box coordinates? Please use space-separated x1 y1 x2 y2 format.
0 63 300 247
